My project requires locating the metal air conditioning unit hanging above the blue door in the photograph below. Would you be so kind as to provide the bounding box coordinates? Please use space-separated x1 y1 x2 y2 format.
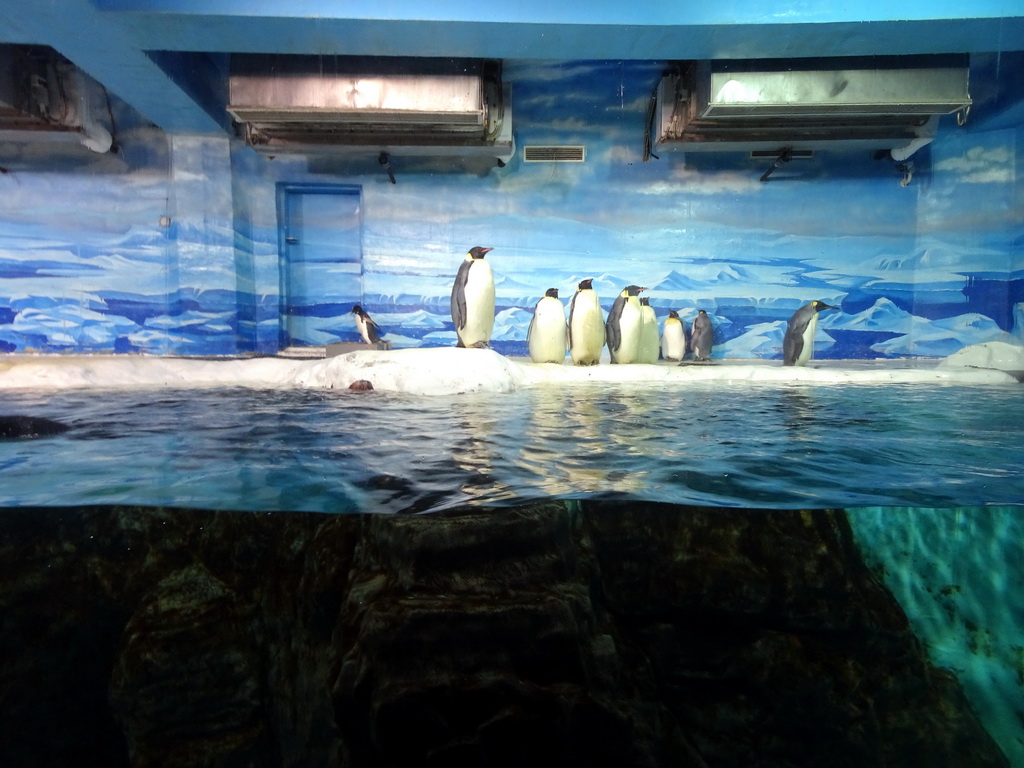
227 55 515 162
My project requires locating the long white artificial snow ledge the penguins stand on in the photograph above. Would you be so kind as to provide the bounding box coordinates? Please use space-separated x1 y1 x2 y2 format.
0 342 1024 395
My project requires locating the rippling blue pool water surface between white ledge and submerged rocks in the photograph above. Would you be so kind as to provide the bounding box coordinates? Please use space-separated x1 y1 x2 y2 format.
0 383 1024 513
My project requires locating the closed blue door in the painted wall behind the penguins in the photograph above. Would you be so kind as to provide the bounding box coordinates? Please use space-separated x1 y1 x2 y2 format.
278 184 362 347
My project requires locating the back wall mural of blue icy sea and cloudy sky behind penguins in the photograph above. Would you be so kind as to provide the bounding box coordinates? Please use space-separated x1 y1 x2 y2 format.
0 61 1024 358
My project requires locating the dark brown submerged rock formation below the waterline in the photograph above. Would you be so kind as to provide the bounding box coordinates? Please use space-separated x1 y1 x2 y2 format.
0 502 1008 768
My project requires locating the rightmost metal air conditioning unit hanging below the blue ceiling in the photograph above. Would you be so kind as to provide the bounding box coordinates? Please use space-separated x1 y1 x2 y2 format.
653 56 971 152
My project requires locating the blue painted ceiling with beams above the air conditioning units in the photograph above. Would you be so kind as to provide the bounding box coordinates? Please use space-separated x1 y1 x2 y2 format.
0 0 1024 133
